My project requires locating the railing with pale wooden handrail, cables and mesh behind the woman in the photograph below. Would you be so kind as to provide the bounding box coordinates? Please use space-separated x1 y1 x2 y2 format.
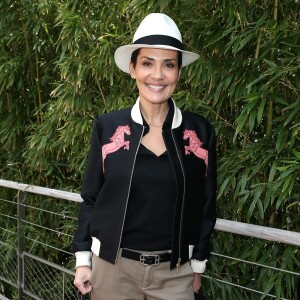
0 179 300 300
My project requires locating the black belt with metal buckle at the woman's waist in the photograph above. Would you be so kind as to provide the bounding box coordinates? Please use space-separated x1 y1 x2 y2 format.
121 249 171 265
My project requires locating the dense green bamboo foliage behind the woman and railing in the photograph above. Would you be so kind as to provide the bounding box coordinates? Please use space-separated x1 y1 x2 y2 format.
0 0 300 299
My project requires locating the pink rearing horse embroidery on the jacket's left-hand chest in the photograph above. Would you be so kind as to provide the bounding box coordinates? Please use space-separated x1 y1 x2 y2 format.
102 125 131 172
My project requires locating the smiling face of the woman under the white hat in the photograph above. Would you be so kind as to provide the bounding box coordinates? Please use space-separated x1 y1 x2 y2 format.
129 48 180 104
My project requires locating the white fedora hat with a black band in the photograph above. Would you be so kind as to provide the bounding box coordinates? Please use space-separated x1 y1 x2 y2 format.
115 13 199 73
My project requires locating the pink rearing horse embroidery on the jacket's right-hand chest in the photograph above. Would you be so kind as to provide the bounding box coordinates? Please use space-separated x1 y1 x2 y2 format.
183 129 208 175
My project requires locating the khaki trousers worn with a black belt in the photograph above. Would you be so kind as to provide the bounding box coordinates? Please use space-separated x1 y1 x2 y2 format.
91 252 194 300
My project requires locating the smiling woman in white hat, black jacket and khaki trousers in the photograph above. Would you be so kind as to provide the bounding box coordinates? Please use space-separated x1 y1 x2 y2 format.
73 13 216 300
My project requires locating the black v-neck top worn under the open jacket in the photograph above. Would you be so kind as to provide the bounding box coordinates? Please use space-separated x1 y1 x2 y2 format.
121 144 177 251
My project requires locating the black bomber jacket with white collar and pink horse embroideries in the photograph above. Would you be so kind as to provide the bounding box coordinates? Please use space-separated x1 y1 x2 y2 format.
73 99 216 273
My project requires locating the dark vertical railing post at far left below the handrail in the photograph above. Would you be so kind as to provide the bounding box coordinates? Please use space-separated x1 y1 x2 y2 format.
17 190 25 300
